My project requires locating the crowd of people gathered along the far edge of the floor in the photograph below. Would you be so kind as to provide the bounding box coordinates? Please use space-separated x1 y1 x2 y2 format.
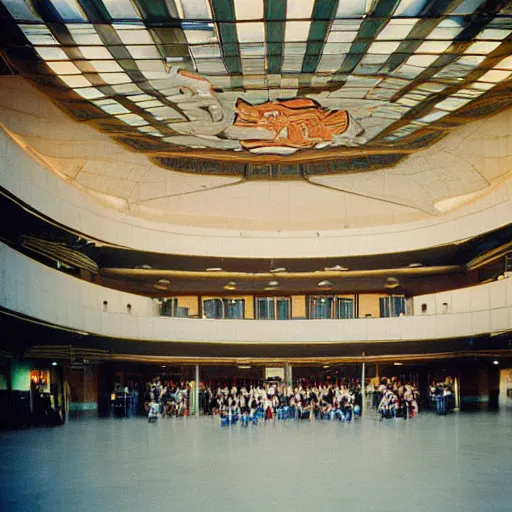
131 377 454 425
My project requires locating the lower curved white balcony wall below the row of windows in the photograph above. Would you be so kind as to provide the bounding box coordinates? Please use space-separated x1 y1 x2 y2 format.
0 244 512 343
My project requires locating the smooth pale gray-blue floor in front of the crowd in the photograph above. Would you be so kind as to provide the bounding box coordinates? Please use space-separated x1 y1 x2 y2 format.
0 412 512 512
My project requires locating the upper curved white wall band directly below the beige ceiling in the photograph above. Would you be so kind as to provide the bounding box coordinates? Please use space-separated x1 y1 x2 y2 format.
0 129 512 258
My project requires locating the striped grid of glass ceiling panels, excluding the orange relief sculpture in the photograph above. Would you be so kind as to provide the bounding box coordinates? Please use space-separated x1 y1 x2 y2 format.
0 0 512 162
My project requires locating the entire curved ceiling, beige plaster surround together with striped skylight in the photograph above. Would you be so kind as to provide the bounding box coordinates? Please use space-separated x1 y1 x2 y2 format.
0 0 512 231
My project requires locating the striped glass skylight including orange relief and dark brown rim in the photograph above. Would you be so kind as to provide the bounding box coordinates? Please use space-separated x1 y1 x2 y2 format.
0 0 512 179
